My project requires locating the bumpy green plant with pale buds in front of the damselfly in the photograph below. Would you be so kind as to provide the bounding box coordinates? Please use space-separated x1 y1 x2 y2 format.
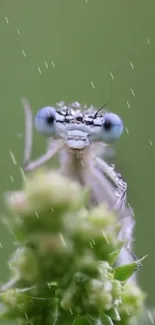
0 169 145 325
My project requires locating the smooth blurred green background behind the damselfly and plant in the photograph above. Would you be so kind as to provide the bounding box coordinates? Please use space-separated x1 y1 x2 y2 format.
0 0 155 304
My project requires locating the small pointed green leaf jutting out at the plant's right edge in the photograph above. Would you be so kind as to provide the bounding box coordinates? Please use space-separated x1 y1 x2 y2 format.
114 255 147 281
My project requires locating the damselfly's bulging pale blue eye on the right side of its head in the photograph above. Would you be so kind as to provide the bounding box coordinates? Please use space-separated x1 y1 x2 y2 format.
100 113 123 143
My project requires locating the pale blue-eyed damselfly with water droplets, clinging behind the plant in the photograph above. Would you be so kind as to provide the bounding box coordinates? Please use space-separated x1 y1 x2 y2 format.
22 98 136 264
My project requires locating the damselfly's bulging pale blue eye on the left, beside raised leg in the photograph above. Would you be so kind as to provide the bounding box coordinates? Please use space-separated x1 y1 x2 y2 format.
35 106 56 136
